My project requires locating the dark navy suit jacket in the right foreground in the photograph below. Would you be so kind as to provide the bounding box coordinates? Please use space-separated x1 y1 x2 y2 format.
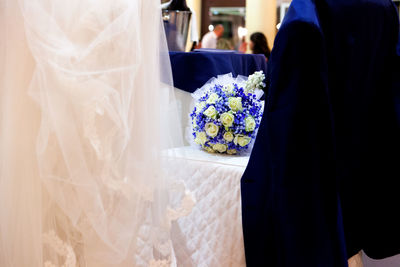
241 0 400 267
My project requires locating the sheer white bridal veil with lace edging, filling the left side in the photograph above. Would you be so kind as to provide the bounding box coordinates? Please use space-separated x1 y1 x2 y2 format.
0 0 193 267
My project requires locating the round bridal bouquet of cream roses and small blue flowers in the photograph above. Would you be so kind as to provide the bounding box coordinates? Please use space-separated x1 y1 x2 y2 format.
190 71 265 155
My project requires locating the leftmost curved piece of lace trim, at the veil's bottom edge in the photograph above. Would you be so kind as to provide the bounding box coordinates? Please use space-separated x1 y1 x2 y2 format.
43 230 76 267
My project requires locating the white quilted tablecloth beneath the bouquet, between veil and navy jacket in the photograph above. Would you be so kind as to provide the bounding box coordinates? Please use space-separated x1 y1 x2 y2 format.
173 147 249 267
